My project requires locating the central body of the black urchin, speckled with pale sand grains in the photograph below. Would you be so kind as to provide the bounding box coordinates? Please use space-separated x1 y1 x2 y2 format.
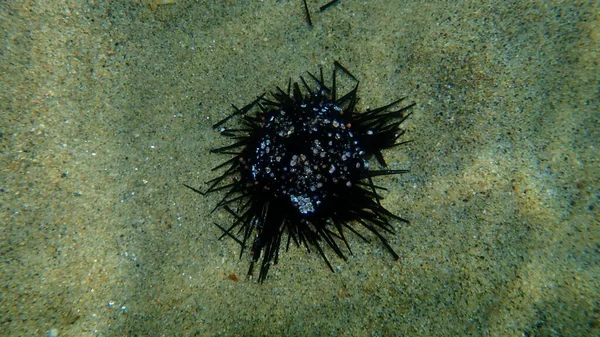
244 100 367 215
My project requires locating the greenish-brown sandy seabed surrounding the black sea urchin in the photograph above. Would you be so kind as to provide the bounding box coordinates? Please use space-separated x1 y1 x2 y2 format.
0 0 600 336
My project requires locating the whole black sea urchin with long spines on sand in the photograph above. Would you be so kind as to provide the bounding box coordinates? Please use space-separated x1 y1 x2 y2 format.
186 62 414 281
